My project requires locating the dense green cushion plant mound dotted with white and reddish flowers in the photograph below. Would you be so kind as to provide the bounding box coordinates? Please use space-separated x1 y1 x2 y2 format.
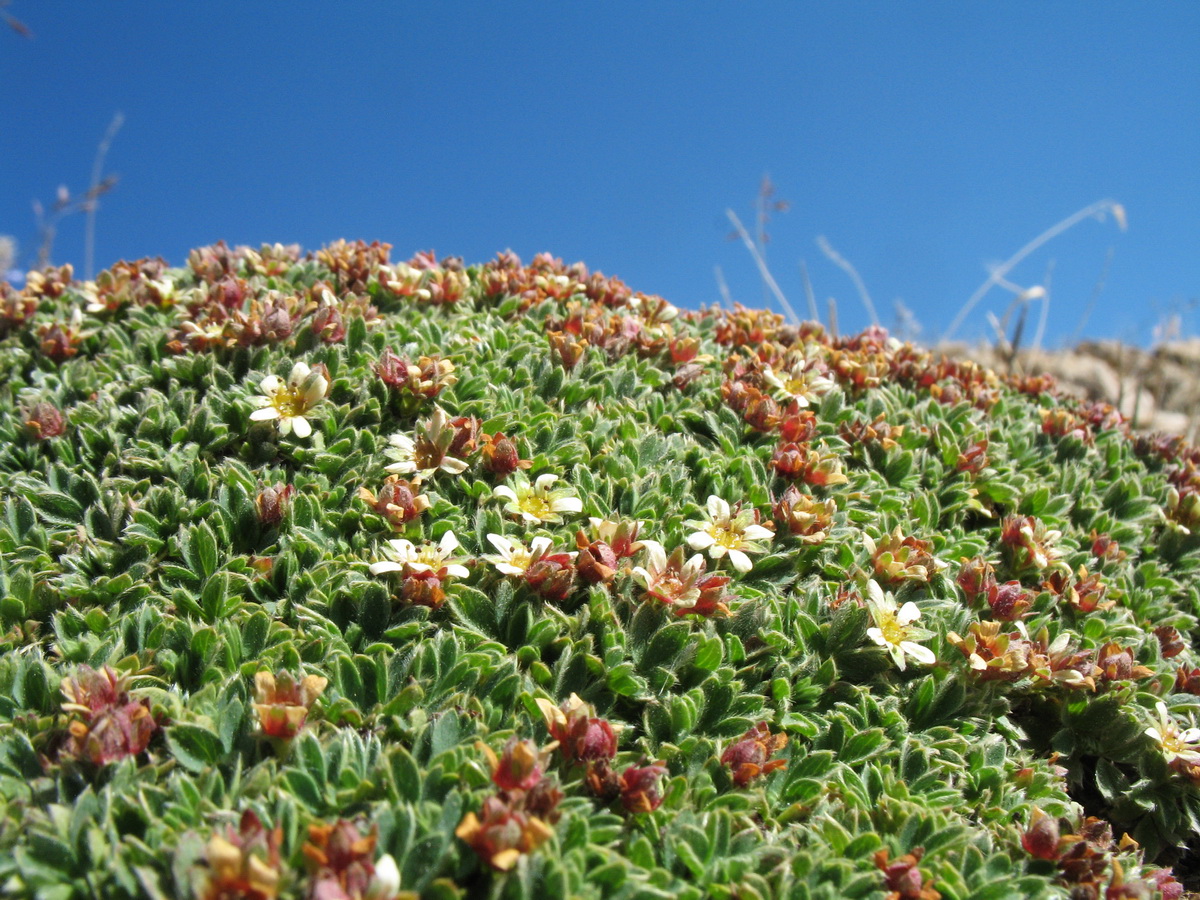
0 242 1200 900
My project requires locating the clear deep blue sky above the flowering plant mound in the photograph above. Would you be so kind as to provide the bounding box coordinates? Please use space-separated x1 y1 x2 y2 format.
0 0 1200 344
